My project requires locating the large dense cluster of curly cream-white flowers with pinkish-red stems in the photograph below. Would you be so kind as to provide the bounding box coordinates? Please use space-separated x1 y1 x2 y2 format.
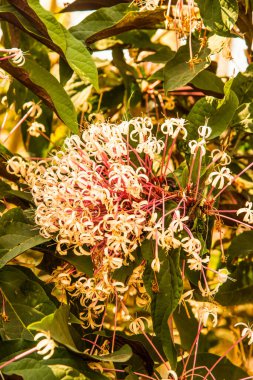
7 117 169 262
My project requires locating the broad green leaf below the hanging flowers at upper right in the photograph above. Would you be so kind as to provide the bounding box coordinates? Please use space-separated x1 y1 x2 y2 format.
163 45 210 92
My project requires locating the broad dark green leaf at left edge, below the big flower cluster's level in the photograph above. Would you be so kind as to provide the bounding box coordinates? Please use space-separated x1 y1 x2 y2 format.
0 266 55 340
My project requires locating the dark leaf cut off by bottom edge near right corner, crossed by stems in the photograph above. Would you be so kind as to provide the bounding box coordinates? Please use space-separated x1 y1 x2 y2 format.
177 353 248 380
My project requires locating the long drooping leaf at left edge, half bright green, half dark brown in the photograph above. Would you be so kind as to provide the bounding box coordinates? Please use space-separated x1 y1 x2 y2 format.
0 58 78 133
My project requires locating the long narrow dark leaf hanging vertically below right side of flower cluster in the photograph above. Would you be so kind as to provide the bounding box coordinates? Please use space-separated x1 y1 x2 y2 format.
144 251 183 368
